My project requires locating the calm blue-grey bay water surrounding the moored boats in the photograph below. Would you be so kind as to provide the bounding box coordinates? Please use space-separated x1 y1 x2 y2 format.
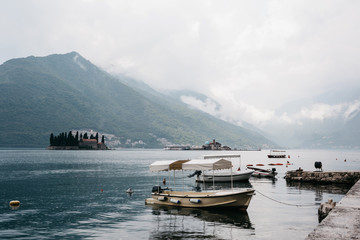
0 149 360 239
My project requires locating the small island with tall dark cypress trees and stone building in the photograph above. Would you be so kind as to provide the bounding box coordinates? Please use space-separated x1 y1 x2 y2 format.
47 131 109 150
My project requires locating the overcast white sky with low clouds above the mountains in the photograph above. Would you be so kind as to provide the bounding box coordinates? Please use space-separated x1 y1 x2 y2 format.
0 0 360 133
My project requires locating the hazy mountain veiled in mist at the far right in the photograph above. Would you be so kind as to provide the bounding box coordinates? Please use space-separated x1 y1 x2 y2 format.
263 86 360 149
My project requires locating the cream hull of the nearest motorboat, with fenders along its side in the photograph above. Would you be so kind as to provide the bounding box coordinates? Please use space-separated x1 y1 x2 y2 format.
145 189 255 210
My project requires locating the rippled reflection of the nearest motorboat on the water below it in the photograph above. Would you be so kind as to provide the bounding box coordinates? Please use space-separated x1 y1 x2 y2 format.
150 206 254 239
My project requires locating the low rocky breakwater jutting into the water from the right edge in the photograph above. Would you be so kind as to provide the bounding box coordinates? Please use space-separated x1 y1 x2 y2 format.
285 170 360 185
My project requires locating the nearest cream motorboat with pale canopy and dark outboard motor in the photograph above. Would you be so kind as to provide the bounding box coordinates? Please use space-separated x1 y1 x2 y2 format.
145 159 255 210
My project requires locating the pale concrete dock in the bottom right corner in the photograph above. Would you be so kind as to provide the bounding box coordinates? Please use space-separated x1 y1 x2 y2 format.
306 180 360 240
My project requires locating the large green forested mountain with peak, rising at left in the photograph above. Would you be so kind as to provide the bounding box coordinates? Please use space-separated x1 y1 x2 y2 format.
0 52 277 148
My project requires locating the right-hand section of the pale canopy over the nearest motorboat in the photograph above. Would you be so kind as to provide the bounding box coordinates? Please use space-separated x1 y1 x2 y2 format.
182 158 232 170
